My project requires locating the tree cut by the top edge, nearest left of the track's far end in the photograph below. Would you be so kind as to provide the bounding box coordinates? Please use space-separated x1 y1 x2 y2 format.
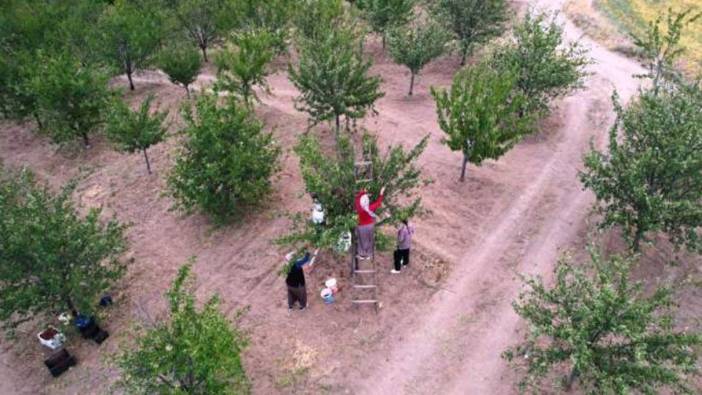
432 0 509 66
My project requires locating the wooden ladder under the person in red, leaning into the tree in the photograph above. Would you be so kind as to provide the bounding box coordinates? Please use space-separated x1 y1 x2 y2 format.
351 161 380 313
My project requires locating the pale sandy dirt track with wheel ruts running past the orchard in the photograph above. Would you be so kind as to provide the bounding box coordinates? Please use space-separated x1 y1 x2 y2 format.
356 0 641 394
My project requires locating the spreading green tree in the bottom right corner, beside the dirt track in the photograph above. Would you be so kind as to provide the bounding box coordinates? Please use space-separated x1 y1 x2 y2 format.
503 251 702 394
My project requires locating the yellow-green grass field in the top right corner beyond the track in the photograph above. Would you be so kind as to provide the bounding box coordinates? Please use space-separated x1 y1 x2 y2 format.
595 0 702 75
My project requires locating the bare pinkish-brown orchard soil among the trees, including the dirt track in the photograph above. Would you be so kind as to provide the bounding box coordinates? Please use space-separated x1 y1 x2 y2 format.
0 0 702 394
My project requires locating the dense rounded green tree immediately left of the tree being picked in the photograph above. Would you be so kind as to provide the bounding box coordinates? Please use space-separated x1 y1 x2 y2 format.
168 95 280 223
